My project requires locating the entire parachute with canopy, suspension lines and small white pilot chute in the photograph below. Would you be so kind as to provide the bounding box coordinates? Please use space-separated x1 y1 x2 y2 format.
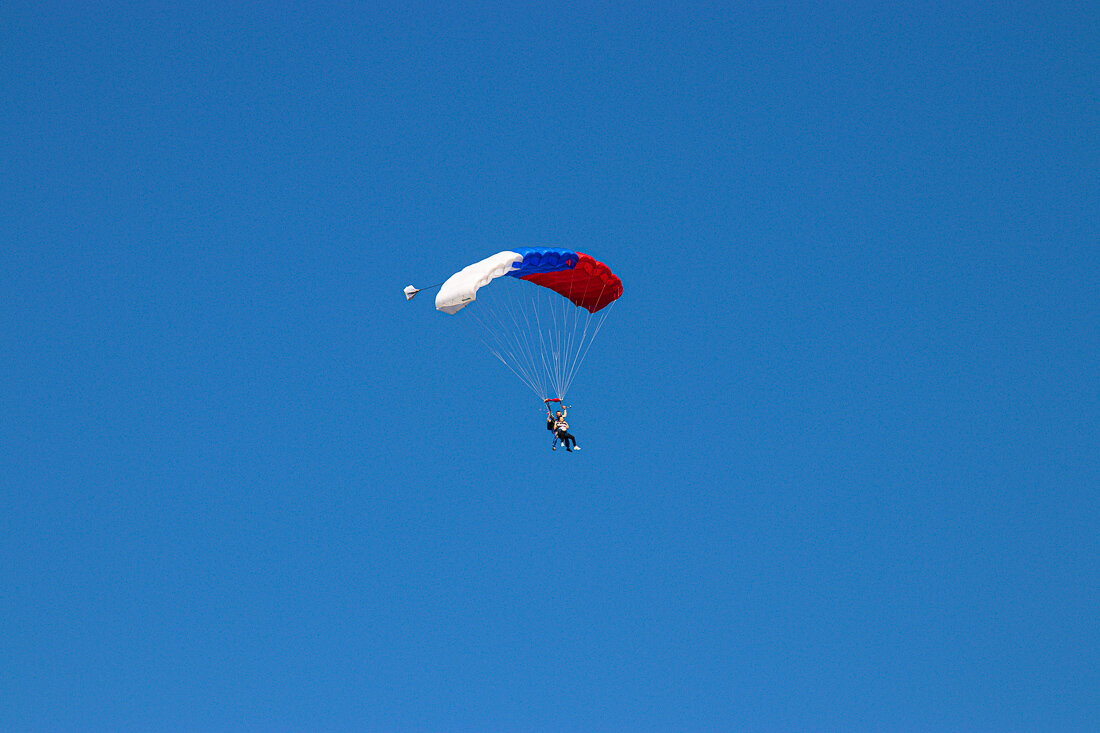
405 247 623 400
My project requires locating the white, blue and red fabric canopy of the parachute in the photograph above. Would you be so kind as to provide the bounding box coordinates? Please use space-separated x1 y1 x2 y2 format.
436 247 623 315
